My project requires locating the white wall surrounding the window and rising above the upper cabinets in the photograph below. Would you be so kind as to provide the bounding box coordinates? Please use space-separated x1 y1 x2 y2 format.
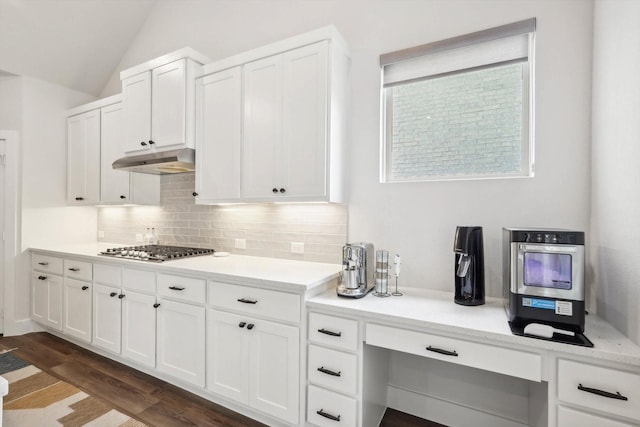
103 0 593 296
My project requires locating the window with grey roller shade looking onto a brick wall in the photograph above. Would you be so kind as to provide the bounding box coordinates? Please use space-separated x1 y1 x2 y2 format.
380 19 535 182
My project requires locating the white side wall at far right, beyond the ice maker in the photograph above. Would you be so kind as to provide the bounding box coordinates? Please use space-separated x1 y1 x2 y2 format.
591 0 640 344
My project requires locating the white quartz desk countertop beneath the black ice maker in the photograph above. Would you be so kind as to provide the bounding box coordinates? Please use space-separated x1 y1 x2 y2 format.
307 288 640 367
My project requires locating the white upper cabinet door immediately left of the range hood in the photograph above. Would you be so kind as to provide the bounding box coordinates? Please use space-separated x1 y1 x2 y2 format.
100 103 132 203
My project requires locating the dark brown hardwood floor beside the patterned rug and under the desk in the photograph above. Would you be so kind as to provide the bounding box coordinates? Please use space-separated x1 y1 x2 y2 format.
0 332 442 427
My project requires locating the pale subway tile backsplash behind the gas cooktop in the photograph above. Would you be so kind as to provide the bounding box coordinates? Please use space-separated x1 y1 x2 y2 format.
98 173 347 263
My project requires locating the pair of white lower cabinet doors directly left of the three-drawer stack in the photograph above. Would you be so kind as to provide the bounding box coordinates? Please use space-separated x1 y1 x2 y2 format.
207 309 300 424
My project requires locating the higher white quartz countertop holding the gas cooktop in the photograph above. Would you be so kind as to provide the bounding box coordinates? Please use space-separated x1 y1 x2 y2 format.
30 243 341 292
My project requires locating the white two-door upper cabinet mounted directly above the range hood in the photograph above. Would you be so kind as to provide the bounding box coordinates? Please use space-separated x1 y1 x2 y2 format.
120 48 208 154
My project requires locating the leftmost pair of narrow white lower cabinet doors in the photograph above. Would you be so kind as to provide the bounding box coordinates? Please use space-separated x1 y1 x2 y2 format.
31 271 62 331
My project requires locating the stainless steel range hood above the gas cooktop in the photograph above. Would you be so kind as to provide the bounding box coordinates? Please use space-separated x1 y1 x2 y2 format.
112 148 196 175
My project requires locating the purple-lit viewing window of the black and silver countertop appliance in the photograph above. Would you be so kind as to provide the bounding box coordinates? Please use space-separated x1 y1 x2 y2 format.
524 252 571 290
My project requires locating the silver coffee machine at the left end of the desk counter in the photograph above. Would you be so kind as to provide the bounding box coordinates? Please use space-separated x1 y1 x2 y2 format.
336 242 375 298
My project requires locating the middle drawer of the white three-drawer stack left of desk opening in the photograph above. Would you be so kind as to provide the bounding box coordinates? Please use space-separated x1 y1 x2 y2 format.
307 345 358 394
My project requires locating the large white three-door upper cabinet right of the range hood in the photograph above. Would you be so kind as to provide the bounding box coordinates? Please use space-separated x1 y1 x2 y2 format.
196 27 349 204
